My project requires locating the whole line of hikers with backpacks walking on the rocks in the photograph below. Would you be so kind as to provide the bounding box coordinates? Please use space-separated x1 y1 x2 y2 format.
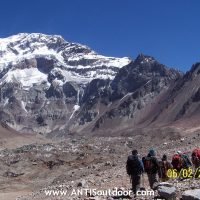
126 149 200 194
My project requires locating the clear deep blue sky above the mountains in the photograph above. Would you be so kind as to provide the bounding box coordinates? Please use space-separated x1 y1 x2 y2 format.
0 0 200 71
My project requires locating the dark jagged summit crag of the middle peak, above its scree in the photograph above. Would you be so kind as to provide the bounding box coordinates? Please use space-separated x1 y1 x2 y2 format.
112 54 179 99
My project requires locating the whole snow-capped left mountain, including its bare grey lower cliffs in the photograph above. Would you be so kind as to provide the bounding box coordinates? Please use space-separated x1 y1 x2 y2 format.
0 33 130 133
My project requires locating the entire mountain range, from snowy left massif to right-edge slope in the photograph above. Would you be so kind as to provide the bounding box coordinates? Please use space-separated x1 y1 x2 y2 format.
0 33 200 136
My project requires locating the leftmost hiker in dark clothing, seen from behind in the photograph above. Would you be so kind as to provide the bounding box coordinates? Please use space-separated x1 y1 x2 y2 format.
126 150 144 195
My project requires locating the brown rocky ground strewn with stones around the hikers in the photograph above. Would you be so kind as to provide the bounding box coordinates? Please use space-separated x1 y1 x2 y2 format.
0 127 200 200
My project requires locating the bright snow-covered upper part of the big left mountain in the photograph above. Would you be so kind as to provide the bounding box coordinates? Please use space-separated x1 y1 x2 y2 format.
0 33 130 87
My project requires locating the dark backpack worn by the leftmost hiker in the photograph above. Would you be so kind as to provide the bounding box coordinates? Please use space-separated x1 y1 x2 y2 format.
126 156 143 175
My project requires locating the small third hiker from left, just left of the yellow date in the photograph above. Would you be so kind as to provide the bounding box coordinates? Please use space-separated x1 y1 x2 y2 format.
158 154 173 182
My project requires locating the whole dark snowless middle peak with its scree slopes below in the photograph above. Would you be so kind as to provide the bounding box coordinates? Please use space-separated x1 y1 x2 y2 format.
69 55 182 134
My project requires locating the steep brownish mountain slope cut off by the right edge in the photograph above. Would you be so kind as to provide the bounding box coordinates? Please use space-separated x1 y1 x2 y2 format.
150 63 200 128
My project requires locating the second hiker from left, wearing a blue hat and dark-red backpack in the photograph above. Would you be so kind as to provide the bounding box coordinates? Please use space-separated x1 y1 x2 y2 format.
143 149 160 189
